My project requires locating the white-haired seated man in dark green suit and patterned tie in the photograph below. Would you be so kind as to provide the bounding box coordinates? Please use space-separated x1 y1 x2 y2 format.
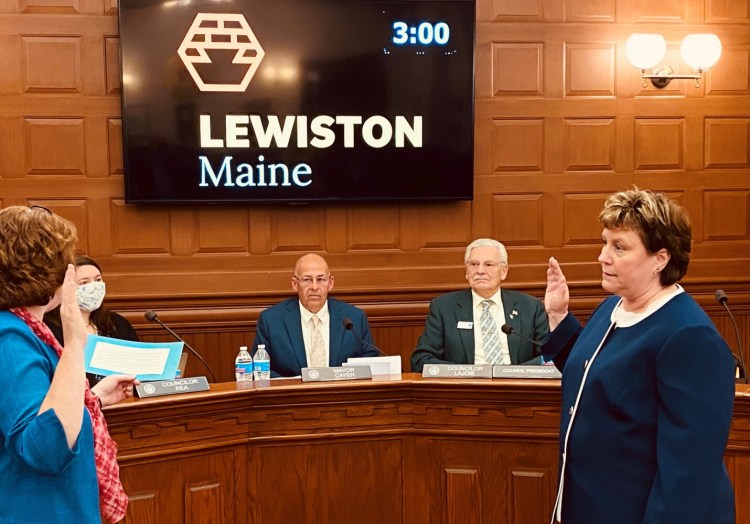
411 238 549 373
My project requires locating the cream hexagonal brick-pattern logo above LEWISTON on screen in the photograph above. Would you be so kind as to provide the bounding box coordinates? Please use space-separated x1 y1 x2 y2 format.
177 13 266 92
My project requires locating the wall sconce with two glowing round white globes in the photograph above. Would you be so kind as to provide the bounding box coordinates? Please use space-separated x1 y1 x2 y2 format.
625 33 721 89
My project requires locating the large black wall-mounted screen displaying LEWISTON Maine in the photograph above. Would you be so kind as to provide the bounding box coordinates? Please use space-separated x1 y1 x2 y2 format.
120 0 475 203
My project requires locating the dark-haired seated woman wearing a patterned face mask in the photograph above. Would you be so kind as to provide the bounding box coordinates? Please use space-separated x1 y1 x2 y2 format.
44 255 138 386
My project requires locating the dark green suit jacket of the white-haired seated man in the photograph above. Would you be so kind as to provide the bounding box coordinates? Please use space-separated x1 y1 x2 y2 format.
411 289 549 373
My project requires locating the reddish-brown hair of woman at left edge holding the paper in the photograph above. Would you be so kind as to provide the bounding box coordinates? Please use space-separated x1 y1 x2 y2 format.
0 206 78 310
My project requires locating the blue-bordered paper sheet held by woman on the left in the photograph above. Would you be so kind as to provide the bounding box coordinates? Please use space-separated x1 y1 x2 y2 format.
84 335 183 381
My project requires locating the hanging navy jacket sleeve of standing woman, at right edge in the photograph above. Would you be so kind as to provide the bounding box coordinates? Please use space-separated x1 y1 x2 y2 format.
643 326 735 524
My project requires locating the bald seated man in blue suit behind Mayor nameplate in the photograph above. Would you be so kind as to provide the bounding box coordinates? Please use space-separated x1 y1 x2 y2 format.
253 254 378 377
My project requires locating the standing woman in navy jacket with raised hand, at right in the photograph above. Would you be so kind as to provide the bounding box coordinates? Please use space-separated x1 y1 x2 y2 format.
542 189 735 524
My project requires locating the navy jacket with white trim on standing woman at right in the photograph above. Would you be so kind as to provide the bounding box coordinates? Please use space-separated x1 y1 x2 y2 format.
542 293 735 524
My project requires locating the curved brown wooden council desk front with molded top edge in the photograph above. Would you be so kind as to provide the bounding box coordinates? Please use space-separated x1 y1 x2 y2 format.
106 374 750 524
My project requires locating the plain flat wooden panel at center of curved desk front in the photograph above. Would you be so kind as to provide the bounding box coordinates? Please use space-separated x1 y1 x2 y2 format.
250 436 404 524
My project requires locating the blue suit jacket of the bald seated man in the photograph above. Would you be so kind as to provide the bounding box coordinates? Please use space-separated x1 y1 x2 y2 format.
253 297 379 377
